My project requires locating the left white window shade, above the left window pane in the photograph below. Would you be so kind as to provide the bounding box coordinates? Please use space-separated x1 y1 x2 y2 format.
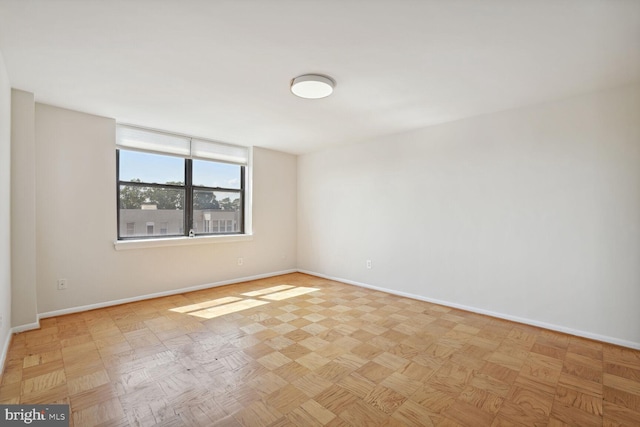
116 125 191 157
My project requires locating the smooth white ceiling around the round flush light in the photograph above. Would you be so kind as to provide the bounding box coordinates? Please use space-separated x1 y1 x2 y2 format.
0 0 640 154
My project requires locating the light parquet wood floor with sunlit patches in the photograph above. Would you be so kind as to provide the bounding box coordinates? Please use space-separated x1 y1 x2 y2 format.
0 274 640 427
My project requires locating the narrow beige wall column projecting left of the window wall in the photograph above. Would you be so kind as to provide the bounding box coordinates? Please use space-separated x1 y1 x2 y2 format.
11 89 38 328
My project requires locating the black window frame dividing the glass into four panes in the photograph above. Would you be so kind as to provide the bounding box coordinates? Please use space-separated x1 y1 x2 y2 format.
116 148 246 240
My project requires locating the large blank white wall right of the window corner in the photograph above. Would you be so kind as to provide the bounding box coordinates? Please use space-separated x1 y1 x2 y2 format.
298 86 640 348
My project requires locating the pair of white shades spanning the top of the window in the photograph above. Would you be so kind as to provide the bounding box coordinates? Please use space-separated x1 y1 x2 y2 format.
116 125 249 165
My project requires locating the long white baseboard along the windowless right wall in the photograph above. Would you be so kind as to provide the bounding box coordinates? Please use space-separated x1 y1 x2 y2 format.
298 269 640 350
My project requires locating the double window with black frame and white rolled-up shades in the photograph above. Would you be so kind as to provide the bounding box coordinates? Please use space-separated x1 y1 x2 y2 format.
116 126 248 240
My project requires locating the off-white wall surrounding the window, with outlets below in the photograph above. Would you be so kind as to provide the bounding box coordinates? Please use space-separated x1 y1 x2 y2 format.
35 104 296 313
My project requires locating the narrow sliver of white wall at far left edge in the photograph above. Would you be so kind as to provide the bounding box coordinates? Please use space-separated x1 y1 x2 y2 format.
0 53 11 370
